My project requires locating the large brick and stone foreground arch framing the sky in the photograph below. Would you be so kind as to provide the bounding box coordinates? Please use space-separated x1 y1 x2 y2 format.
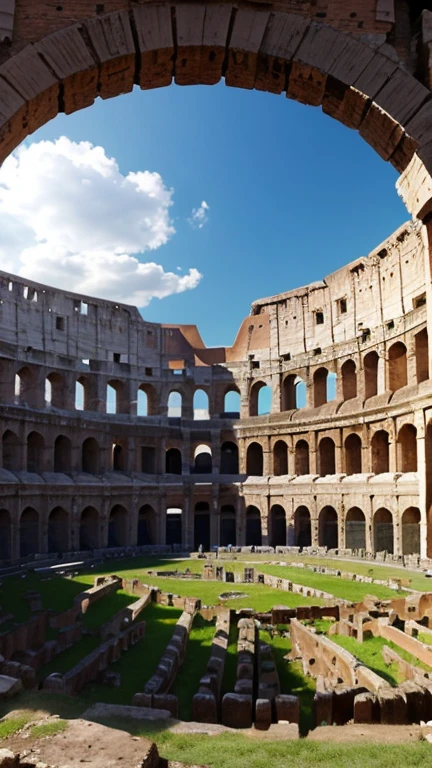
0 2 432 217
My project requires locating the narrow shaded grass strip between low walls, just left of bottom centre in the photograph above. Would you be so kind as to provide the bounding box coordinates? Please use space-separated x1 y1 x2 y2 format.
171 614 215 720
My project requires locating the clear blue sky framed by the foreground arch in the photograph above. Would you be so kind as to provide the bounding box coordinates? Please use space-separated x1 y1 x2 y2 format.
17 84 409 346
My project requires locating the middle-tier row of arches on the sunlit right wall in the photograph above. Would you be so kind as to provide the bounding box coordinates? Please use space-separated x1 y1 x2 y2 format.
246 424 417 477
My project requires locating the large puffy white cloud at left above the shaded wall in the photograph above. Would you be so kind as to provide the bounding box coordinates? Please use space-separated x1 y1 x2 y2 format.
0 136 201 307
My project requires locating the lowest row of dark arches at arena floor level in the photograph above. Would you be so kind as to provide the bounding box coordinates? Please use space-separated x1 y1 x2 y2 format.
0 502 420 560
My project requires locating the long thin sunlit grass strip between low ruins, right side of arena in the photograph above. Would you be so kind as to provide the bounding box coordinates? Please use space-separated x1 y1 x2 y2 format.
260 565 402 602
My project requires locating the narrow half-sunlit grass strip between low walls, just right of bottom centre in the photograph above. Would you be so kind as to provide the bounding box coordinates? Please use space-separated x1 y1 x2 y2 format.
260 630 316 735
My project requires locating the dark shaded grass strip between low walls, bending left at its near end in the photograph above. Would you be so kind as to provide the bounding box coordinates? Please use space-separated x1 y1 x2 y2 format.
80 603 181 705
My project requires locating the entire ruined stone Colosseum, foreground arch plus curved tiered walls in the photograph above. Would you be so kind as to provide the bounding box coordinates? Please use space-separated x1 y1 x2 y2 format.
0 0 432 562
